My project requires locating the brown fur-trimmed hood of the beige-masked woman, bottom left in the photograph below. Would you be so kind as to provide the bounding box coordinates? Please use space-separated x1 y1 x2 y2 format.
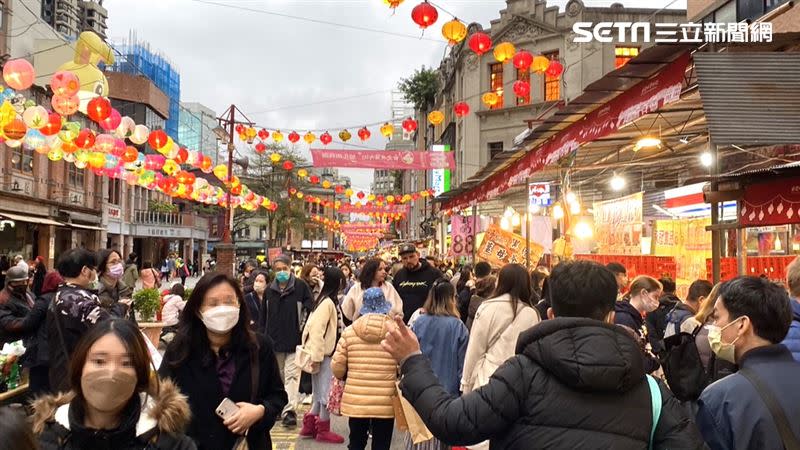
33 379 191 436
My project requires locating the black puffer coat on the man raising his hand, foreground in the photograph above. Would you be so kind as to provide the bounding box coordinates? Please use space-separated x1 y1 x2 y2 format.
401 318 704 450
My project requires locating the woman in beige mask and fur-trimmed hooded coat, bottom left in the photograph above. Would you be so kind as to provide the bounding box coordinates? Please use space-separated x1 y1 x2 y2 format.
33 319 196 450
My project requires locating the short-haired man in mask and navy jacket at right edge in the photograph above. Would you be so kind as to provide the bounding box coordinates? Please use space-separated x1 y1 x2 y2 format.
697 277 800 450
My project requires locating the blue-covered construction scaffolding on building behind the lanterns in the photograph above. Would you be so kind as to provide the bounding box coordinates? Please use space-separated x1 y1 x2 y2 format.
106 31 181 136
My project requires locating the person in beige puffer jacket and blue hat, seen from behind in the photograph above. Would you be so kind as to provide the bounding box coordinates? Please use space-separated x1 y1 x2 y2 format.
331 288 397 450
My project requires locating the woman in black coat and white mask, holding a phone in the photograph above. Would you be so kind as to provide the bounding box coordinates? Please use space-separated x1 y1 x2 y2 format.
159 272 287 450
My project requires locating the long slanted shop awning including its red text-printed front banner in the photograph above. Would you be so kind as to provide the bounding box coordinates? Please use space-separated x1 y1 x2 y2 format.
443 46 690 209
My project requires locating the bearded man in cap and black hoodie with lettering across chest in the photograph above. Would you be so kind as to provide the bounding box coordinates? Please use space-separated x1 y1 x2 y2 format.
392 244 442 323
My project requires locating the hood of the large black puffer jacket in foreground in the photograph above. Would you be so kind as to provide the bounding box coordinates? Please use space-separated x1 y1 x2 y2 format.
517 318 645 393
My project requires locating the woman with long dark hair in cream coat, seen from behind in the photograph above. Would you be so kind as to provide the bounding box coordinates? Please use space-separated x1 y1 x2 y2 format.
461 264 540 393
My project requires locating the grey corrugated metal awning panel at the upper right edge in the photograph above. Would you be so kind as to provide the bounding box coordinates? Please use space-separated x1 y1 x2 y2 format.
694 52 800 145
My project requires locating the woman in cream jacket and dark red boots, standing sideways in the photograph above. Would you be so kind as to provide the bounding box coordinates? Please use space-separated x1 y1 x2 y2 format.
300 267 344 444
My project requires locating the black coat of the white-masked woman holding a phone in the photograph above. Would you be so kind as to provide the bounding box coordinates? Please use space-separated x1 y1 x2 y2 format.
158 334 288 450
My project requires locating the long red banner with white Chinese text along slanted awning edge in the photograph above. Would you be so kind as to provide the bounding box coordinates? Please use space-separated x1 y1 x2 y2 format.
443 53 690 209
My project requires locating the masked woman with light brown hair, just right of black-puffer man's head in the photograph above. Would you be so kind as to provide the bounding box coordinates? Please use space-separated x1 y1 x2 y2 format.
614 275 663 373
